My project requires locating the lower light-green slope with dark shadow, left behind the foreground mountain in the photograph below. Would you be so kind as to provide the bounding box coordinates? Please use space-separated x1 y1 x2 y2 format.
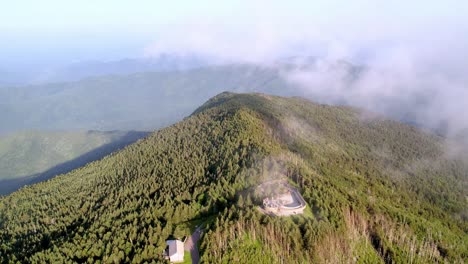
0 131 147 194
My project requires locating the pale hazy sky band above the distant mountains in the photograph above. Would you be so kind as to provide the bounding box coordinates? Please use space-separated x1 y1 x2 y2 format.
0 0 468 68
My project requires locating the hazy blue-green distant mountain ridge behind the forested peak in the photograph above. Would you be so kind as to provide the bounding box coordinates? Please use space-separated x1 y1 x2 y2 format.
0 65 291 134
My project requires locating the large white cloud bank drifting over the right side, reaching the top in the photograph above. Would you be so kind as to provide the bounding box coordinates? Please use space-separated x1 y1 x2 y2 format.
145 1 468 146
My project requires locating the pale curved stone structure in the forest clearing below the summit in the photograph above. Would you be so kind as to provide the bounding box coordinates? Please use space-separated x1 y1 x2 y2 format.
257 180 306 216
